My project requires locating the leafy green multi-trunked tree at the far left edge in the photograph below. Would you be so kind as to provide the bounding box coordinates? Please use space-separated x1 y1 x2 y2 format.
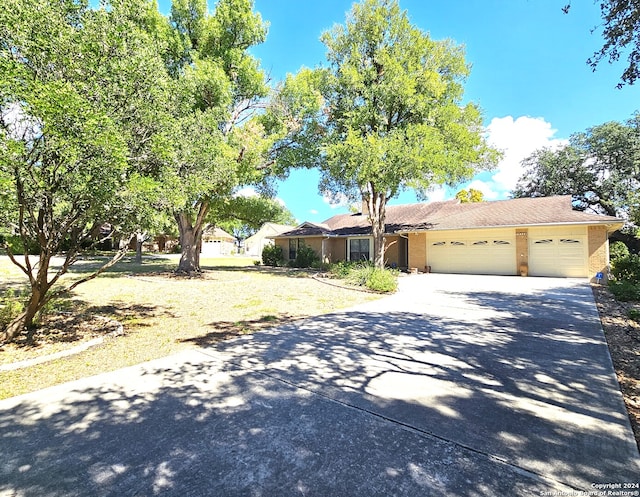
0 0 171 340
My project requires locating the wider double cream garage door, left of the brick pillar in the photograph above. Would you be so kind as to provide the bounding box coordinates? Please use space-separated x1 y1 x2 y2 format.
427 229 516 275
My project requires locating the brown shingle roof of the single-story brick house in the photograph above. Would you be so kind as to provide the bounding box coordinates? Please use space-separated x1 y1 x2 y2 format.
282 195 623 237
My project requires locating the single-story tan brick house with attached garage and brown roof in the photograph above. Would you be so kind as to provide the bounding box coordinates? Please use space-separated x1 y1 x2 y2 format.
274 195 623 279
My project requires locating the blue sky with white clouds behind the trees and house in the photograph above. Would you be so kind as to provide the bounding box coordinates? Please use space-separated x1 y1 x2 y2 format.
160 0 640 222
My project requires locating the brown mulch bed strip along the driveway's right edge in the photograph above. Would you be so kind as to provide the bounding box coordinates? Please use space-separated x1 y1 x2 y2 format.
591 285 640 447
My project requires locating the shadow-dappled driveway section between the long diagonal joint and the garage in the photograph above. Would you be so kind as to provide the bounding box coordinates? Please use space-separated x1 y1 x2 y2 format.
206 280 640 490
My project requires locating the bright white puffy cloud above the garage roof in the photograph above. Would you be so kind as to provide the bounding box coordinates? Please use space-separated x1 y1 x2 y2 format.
482 116 568 195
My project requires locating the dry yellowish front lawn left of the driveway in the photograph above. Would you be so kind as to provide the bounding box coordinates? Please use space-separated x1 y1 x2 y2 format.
0 258 379 398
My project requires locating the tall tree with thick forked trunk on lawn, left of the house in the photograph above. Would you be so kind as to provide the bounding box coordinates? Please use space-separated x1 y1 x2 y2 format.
153 0 300 273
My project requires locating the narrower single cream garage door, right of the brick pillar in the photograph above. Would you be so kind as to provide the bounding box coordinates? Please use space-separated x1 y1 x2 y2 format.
529 228 588 278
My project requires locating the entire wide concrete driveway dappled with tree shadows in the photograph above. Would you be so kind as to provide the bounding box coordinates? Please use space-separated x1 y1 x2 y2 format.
0 274 640 497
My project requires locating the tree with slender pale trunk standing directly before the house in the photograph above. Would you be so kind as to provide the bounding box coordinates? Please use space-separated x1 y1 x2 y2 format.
287 0 498 267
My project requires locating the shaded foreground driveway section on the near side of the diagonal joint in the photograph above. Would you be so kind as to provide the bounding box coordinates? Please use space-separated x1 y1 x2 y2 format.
0 351 552 497
